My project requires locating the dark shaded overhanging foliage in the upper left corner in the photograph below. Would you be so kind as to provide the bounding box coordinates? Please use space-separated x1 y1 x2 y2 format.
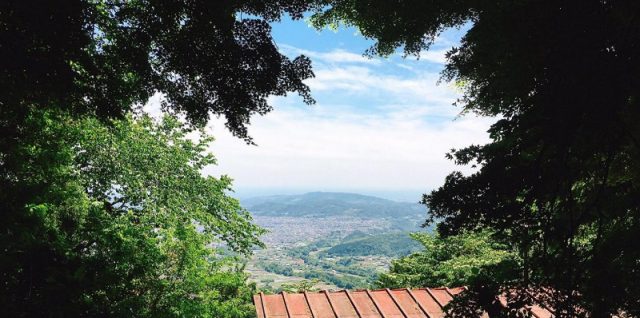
0 0 313 140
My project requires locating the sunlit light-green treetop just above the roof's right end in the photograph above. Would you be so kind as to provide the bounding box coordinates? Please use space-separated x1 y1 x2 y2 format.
375 232 518 288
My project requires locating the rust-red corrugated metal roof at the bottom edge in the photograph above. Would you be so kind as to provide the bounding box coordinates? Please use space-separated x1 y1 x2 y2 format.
253 287 553 318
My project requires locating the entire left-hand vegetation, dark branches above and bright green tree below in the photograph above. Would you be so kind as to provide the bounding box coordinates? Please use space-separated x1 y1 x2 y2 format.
0 0 313 317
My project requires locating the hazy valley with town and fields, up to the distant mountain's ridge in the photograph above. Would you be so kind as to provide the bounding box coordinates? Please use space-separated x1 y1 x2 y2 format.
242 192 425 291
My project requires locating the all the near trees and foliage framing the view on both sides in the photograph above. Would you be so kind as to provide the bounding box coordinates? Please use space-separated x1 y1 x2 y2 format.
0 0 640 317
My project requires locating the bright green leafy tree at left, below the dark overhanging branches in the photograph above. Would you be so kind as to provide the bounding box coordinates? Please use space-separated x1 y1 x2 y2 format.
0 111 264 317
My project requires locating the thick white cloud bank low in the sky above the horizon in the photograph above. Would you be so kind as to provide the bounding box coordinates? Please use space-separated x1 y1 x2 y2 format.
206 106 491 190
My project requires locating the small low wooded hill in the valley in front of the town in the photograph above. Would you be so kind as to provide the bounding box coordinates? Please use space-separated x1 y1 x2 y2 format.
326 233 420 257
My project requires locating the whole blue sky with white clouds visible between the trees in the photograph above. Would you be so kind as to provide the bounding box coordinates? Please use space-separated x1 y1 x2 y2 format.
150 19 495 201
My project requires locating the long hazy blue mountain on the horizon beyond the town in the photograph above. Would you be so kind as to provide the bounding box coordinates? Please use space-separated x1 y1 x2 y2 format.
241 192 425 219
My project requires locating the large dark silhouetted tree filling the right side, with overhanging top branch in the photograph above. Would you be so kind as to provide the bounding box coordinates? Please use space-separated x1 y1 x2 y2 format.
313 0 640 317
